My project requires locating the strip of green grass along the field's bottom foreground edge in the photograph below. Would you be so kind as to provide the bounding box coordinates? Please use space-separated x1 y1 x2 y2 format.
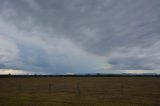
0 95 151 106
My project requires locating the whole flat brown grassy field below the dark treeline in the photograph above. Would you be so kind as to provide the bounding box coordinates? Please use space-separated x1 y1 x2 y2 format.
0 77 160 106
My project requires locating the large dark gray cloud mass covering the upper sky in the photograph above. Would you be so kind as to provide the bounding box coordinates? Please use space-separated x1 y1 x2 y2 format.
1 0 160 52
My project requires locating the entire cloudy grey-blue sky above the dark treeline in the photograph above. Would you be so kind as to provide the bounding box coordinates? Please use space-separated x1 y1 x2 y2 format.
0 0 160 74
